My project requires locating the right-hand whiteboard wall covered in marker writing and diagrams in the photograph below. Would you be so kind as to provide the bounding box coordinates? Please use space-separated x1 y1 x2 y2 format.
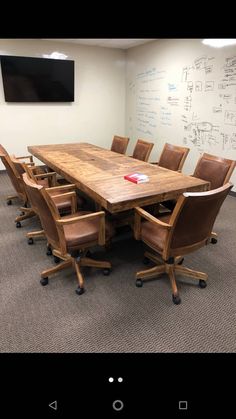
126 39 236 190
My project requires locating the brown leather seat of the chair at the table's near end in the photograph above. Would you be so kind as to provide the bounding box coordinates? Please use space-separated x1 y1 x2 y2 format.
141 215 171 253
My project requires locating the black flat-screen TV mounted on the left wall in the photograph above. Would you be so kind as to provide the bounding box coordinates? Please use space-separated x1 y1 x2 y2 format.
0 55 74 102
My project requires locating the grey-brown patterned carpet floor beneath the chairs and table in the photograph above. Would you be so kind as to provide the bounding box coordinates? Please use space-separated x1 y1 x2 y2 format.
0 173 236 353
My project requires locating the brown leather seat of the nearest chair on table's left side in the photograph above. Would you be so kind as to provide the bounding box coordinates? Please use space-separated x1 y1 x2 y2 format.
63 211 115 252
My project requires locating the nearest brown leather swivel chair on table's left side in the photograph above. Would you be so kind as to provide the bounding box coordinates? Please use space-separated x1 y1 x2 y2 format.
23 173 114 295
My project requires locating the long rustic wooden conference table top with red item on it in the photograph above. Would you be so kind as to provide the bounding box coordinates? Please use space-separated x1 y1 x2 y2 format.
28 143 209 213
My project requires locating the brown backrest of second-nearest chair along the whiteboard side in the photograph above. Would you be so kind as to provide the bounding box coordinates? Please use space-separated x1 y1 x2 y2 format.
158 143 189 171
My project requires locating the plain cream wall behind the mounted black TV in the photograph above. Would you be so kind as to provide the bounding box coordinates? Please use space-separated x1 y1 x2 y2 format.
0 39 125 169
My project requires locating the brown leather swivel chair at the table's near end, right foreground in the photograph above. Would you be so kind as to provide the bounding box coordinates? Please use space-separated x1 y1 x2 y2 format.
134 183 233 304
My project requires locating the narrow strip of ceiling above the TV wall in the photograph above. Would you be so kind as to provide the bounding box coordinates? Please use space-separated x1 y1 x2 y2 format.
42 38 155 49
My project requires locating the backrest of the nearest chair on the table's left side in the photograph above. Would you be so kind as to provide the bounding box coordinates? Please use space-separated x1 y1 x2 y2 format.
22 173 60 249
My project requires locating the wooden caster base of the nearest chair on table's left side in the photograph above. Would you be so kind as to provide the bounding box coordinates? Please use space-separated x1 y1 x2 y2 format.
40 250 111 295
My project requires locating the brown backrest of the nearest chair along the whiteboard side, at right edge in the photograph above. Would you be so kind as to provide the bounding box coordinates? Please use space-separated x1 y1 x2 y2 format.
193 153 236 189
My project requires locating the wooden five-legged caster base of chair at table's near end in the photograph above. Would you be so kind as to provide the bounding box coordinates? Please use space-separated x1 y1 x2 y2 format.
136 252 208 304
